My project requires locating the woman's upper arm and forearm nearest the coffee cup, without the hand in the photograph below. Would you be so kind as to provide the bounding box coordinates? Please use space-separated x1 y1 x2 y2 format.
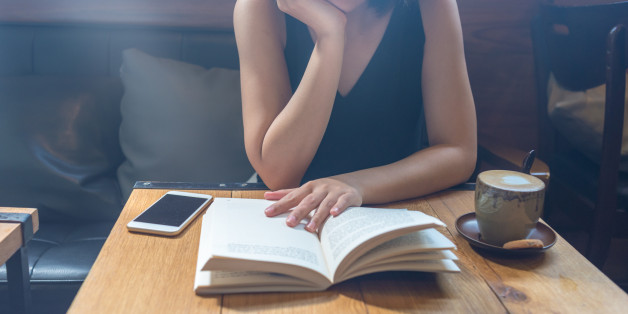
354 0 477 203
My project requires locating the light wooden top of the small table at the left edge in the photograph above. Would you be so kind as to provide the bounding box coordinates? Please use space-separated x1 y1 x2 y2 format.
0 207 39 265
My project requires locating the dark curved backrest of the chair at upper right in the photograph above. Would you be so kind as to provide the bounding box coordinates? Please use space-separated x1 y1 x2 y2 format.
532 1 628 160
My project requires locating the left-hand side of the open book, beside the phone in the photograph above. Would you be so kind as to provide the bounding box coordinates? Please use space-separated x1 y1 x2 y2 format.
199 198 330 282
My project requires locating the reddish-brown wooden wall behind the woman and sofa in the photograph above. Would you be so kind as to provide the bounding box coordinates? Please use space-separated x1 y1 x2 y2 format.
0 0 612 155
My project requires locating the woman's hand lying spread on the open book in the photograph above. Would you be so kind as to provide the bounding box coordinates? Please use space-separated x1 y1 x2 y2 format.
264 177 362 232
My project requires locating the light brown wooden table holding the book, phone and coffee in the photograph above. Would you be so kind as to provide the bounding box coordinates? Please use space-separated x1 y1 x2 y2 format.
69 185 628 313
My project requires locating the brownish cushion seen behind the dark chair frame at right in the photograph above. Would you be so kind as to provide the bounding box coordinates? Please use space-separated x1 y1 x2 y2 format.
547 74 628 171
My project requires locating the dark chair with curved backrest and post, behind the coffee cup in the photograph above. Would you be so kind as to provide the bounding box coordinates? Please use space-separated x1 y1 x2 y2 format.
532 1 628 267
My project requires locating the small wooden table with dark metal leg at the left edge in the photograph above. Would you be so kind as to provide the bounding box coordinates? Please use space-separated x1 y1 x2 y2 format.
0 207 39 313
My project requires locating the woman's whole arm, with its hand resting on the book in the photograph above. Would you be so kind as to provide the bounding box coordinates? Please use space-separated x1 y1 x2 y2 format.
267 0 477 231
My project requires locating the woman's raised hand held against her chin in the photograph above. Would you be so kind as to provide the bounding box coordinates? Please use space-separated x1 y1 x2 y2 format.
277 0 347 39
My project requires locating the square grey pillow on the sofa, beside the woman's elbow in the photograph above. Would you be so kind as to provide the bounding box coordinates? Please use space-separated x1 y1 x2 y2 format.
118 49 253 197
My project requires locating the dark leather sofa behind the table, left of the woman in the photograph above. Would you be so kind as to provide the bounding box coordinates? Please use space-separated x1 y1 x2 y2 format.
0 24 238 313
